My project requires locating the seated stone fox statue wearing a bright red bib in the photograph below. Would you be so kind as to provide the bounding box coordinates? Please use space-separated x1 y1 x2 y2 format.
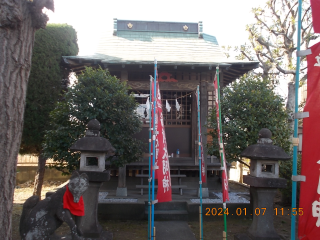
20 171 89 240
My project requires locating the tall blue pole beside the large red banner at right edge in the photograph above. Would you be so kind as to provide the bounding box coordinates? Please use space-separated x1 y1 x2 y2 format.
291 0 302 240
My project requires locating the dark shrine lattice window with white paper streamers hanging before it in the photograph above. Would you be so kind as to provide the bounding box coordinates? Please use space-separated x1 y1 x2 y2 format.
132 91 193 126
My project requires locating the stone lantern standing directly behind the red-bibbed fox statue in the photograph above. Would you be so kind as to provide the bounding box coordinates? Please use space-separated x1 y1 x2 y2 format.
70 119 115 239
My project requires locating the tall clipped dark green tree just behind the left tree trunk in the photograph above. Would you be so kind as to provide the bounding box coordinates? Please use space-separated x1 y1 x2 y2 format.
20 24 78 154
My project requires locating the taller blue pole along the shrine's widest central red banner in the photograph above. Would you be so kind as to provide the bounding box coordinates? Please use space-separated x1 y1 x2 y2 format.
151 59 157 238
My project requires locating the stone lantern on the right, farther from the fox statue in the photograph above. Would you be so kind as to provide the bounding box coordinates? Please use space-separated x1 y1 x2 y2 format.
234 128 290 240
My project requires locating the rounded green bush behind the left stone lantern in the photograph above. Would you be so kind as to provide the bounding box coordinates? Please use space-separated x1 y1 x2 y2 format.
44 68 142 174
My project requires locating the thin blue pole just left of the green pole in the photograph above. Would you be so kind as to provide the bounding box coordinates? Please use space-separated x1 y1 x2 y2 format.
197 85 203 240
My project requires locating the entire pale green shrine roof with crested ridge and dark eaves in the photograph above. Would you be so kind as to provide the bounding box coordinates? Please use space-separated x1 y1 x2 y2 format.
63 19 258 83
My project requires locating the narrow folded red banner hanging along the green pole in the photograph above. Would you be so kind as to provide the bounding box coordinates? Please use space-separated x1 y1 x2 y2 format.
213 74 229 202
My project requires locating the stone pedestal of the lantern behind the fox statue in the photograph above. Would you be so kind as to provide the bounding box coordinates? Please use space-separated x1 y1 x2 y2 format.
76 171 110 240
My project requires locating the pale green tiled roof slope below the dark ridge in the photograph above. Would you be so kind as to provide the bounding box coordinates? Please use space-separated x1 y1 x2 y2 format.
90 31 228 65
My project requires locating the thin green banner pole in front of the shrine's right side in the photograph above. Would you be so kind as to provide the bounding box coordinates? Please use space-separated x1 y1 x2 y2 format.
216 66 227 240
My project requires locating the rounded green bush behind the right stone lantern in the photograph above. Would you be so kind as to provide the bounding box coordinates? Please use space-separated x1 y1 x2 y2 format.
208 75 291 162
